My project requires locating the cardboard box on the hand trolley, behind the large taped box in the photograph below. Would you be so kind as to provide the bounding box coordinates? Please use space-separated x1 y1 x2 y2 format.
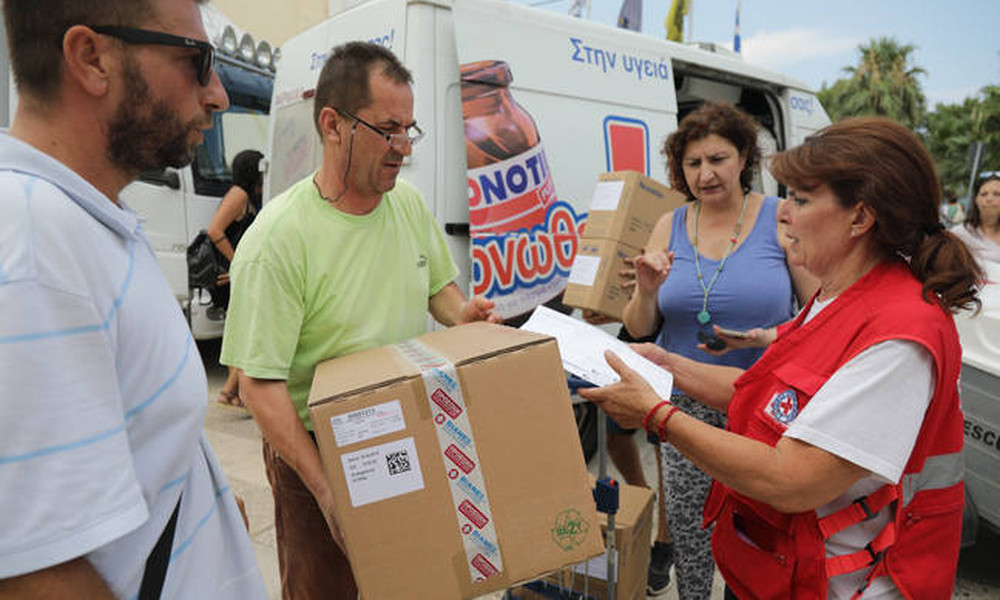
515 483 655 600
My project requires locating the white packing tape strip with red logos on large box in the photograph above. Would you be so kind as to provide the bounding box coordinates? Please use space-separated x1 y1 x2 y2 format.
396 340 503 583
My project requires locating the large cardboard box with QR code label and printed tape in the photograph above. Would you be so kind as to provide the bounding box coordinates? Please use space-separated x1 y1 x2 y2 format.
309 323 602 600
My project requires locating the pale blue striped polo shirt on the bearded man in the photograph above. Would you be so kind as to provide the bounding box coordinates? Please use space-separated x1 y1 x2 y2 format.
0 135 266 600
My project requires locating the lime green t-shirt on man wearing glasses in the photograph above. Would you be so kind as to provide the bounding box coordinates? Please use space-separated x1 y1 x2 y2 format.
219 176 458 429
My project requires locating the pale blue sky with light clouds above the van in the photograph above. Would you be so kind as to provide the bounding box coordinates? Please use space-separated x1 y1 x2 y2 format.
514 0 1000 109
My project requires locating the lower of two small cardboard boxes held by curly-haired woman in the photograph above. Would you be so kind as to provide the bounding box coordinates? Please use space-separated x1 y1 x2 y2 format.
563 238 639 320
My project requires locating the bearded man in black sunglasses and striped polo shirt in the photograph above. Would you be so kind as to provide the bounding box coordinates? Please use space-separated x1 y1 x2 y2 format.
0 0 267 600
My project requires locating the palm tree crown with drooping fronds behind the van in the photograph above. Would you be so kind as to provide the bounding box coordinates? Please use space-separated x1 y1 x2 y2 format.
817 37 926 129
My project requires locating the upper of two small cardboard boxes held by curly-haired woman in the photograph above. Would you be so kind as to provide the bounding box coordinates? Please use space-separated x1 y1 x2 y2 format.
583 171 684 248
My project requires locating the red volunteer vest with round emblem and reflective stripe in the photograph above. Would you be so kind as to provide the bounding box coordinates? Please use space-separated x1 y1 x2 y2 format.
705 263 964 600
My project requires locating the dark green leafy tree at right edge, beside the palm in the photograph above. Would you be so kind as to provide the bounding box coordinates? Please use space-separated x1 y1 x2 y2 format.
924 85 1000 195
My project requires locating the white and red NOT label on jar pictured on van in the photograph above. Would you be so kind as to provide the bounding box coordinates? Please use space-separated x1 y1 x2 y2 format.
467 144 556 235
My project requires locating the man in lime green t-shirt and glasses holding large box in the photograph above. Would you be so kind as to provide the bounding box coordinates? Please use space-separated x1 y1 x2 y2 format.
220 42 500 600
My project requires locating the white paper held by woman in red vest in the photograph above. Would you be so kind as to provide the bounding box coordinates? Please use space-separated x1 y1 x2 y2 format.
521 306 674 399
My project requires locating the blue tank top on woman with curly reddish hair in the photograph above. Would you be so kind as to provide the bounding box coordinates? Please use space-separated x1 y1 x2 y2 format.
656 196 793 391
